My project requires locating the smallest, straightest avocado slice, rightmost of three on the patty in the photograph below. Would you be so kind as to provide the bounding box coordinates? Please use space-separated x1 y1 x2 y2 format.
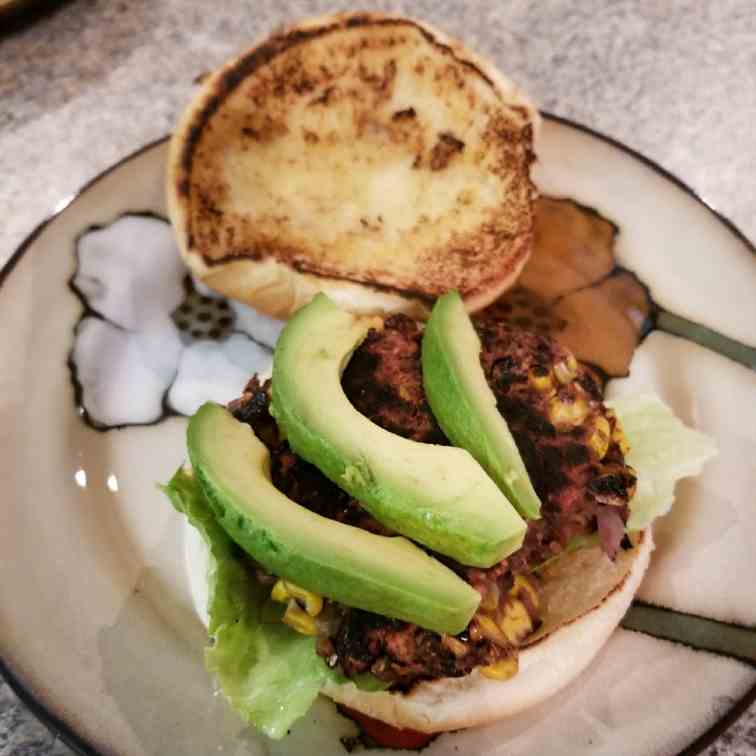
422 291 541 519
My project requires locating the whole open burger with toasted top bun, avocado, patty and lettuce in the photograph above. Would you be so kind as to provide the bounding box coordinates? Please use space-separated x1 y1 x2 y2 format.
164 14 713 738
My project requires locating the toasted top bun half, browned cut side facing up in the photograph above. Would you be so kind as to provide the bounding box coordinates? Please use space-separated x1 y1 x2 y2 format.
167 13 538 318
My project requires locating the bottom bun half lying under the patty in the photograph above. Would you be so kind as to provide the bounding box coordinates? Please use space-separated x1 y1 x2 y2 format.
323 529 653 733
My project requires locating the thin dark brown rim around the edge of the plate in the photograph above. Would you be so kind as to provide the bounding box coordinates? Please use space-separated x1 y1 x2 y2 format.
0 110 756 756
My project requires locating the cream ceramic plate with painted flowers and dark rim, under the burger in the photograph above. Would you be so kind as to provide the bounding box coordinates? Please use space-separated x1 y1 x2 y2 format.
0 117 756 756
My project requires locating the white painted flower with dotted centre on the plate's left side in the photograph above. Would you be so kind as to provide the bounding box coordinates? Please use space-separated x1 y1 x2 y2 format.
69 213 283 429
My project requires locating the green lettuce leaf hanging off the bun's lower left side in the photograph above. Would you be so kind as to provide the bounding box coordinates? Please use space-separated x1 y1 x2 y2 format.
162 469 342 739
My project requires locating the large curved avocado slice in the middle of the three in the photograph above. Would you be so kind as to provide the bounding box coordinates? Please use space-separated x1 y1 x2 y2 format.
271 294 526 567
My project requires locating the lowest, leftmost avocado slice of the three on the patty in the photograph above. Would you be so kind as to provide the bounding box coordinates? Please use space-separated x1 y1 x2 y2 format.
187 403 480 634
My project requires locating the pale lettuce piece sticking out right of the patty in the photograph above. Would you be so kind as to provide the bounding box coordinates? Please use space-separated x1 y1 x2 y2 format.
606 394 717 531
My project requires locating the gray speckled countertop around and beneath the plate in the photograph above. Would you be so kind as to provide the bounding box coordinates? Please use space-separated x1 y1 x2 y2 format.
0 0 756 756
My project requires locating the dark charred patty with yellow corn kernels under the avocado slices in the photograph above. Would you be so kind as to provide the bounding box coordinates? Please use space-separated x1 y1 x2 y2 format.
229 315 636 688
